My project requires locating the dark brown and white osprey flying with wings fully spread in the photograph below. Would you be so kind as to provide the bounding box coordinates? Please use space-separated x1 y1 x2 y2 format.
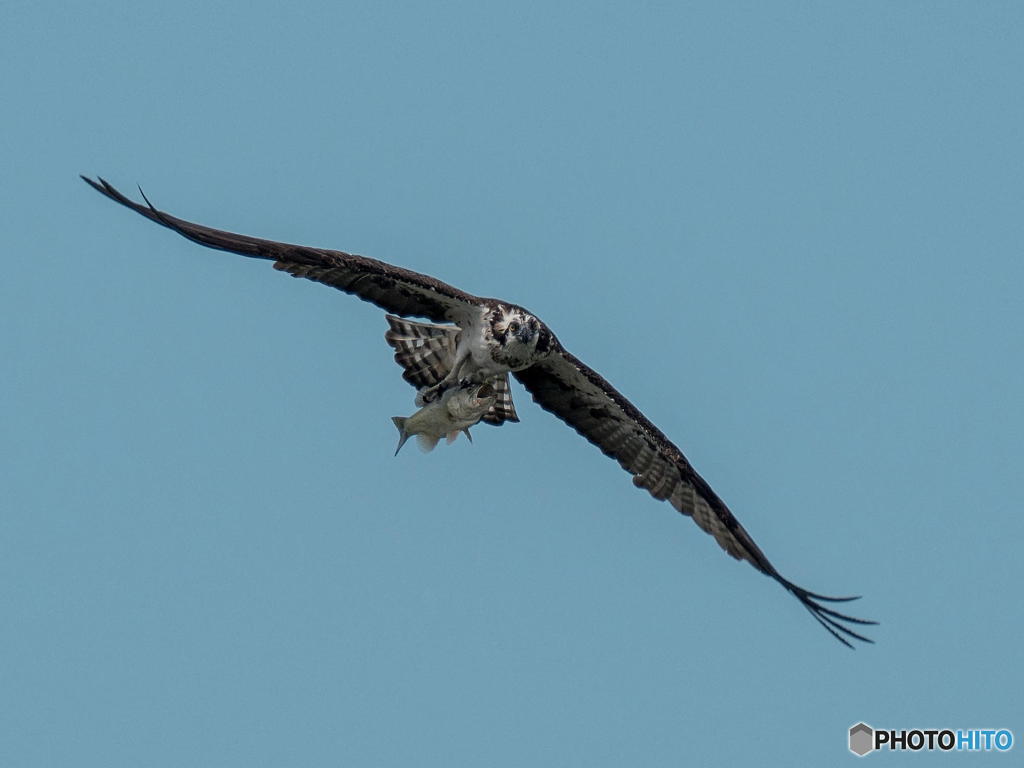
82 176 878 648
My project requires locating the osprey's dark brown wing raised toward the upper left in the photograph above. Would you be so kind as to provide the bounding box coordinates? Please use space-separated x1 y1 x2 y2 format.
82 176 479 323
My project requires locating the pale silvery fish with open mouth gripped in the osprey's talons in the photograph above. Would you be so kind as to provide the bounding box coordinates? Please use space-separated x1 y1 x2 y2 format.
391 382 498 456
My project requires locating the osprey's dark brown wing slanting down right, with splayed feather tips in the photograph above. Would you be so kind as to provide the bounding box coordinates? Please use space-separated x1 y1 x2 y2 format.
513 344 877 647
